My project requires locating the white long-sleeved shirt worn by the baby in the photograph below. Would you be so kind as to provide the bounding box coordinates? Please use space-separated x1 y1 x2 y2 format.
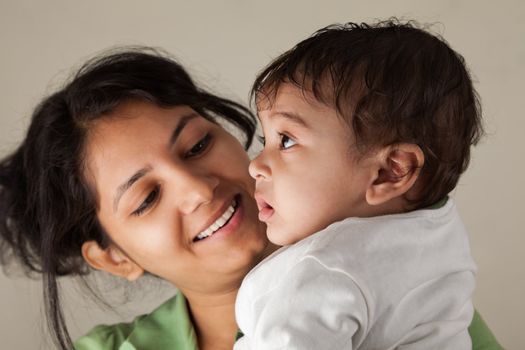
235 199 476 350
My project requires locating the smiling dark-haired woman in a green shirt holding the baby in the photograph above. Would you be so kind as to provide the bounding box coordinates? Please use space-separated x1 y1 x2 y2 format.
0 50 500 350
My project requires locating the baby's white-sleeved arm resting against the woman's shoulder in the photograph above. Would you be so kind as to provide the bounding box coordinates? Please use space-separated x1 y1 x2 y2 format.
235 258 368 350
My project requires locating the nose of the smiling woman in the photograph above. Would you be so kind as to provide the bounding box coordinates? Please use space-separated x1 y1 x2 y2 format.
175 172 219 214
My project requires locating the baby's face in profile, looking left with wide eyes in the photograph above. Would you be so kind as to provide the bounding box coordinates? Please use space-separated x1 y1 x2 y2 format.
249 84 374 245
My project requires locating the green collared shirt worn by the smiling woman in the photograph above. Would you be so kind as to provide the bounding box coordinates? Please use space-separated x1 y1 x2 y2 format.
75 294 503 350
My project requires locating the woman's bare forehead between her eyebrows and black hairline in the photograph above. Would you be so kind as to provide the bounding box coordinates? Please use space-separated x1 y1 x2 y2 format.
85 103 195 197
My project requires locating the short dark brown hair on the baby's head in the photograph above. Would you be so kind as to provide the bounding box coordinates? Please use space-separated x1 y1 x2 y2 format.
251 19 483 209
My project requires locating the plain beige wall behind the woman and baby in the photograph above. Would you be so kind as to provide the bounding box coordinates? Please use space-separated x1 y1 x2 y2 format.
0 0 525 349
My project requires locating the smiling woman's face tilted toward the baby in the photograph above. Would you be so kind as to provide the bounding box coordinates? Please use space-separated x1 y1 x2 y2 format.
86 101 268 293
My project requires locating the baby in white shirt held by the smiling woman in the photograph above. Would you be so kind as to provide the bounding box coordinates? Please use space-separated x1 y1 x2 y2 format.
235 21 483 350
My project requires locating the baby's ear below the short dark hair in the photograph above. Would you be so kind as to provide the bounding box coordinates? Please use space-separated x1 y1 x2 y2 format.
366 143 425 205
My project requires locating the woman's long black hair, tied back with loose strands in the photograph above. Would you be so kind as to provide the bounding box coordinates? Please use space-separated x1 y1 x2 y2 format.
0 48 256 349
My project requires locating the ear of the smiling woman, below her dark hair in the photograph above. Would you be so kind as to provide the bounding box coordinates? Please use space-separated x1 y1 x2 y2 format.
82 241 144 281
